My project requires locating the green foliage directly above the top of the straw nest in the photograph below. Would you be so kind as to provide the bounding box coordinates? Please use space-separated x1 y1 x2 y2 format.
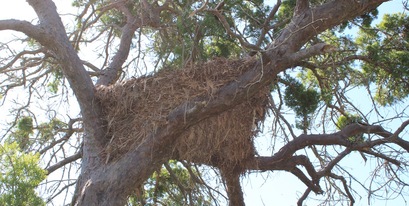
147 1 245 67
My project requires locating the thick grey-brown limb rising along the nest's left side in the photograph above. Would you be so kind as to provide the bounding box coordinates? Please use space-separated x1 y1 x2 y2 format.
27 0 106 153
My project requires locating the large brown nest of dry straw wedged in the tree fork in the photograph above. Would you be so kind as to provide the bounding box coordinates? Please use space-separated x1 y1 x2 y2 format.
97 58 268 167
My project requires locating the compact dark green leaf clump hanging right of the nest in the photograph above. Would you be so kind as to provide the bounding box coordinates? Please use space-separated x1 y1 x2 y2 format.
284 78 320 130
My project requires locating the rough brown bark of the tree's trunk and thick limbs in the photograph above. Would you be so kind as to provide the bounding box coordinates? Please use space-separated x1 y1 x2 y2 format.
0 0 392 206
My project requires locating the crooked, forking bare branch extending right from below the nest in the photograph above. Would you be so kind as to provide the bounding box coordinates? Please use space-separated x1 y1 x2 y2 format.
242 120 400 198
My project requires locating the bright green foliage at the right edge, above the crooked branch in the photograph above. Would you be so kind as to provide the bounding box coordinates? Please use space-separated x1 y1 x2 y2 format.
357 13 409 106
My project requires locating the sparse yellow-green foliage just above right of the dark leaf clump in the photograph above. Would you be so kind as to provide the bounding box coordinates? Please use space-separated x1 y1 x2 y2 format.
297 30 366 105
